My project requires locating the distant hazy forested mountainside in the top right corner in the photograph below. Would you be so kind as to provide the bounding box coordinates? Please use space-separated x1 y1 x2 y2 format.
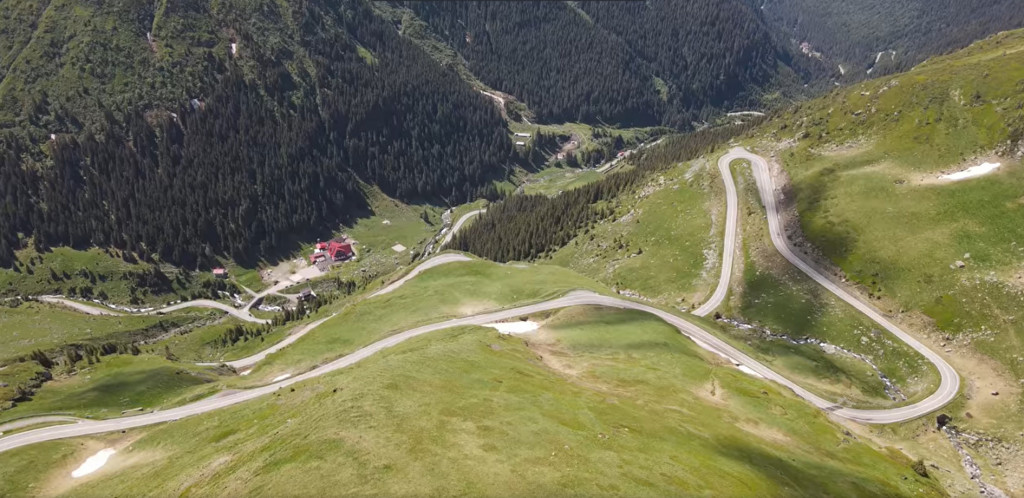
751 0 1024 79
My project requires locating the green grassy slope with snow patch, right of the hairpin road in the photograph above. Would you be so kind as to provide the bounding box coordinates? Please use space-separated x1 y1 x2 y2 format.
765 31 1024 433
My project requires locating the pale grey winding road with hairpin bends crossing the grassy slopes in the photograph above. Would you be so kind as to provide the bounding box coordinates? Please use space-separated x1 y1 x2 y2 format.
0 149 959 452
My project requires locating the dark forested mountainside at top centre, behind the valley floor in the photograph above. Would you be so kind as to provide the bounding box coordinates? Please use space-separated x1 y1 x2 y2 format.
401 0 792 128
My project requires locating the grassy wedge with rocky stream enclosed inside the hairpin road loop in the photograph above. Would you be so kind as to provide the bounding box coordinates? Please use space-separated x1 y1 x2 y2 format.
725 162 938 407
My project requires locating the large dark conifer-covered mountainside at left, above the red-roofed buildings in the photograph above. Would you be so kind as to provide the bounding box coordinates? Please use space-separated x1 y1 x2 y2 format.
0 0 512 264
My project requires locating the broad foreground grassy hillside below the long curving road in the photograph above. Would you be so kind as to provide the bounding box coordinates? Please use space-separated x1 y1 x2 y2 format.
0 310 941 496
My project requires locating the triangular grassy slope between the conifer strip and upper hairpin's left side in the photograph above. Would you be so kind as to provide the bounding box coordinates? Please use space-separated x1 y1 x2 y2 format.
551 155 724 307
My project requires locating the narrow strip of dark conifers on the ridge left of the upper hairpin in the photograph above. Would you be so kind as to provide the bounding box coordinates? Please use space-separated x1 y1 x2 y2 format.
449 123 757 262
